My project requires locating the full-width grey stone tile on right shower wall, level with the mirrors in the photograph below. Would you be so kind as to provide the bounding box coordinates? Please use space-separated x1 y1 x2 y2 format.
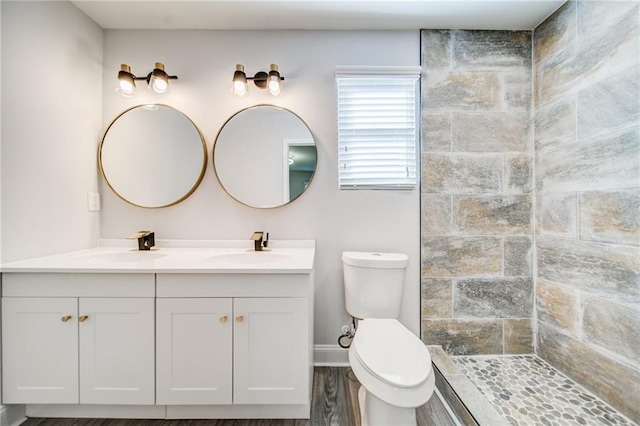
536 126 640 192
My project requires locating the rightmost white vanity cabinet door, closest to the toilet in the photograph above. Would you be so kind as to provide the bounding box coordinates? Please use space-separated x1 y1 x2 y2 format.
233 298 310 404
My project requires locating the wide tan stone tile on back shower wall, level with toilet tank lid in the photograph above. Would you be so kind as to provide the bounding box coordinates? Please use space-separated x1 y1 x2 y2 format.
421 237 502 277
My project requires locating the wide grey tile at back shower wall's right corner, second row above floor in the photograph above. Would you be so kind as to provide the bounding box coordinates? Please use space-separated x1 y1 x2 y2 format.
453 277 533 318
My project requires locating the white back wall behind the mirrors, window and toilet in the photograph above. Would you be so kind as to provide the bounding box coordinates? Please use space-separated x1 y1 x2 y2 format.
100 30 420 344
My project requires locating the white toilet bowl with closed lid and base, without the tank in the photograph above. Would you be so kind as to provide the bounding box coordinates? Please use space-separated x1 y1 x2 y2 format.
349 318 435 426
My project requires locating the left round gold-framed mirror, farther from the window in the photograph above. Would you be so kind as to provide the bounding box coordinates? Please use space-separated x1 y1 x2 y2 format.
98 105 207 208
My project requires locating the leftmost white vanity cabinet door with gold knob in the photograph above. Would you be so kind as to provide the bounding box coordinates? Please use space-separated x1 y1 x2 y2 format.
2 298 78 404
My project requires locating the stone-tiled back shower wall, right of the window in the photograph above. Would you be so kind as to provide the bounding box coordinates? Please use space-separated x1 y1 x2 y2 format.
421 30 534 354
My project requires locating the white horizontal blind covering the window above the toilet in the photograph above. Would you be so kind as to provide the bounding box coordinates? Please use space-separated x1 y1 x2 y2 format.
336 67 420 189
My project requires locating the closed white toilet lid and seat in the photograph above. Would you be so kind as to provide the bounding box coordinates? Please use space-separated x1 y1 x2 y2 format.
349 318 434 407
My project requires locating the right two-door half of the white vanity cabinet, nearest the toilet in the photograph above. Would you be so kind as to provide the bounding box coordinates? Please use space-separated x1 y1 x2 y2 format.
156 274 313 418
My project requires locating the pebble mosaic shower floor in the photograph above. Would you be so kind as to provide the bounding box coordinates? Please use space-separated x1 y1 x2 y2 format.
452 355 636 426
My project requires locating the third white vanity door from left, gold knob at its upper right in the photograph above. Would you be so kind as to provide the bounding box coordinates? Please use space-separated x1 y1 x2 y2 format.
156 298 233 405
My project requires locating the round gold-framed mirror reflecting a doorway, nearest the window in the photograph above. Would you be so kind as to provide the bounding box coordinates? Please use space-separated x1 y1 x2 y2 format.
213 105 318 208
